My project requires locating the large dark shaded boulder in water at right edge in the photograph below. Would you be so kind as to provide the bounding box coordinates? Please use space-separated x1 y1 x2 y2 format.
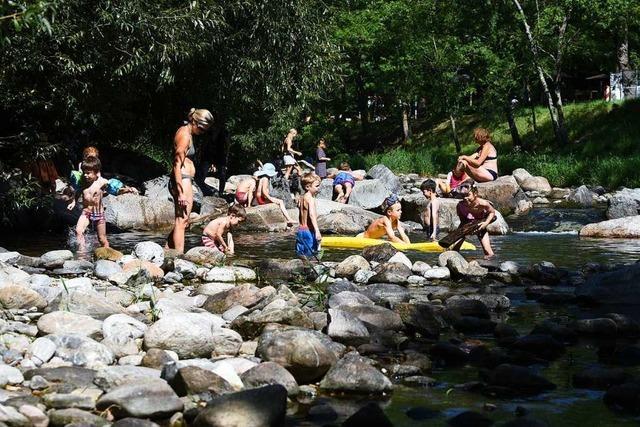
576 264 640 305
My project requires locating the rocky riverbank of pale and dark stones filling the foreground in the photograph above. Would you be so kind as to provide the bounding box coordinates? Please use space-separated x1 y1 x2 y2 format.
0 242 640 426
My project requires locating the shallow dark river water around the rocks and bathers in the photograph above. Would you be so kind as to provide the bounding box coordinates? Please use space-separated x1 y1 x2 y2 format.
0 209 640 427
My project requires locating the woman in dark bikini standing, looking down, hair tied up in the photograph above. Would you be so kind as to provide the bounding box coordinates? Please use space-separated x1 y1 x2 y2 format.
167 108 213 253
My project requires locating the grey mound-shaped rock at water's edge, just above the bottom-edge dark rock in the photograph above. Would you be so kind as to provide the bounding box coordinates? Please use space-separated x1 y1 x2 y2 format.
320 355 393 394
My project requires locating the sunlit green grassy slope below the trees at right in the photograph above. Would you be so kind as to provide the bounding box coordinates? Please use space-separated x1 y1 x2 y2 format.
351 101 640 189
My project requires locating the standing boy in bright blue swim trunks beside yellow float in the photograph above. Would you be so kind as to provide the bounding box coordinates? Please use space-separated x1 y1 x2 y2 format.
296 172 322 257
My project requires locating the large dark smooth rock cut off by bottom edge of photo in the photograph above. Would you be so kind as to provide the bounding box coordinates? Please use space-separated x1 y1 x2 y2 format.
194 385 287 427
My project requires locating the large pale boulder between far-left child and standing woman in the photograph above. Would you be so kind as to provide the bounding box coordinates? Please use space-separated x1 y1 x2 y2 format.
103 194 175 231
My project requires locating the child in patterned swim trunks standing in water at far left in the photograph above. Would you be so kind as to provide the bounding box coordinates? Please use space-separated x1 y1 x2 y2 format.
76 156 109 251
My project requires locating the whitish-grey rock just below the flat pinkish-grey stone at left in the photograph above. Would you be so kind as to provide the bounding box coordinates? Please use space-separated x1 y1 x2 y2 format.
47 334 114 368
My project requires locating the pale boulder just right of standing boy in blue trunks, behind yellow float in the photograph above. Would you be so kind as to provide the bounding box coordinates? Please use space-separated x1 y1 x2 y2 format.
316 199 380 234
